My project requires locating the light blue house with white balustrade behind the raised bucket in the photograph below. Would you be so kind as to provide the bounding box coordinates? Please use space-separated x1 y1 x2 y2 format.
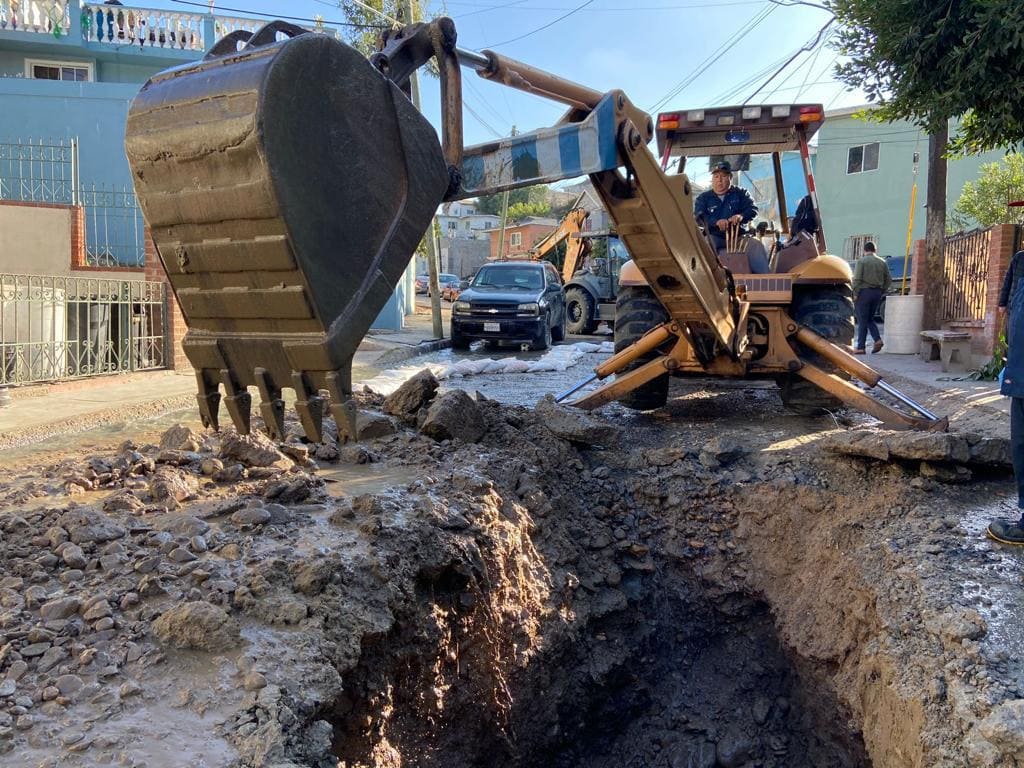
0 0 413 329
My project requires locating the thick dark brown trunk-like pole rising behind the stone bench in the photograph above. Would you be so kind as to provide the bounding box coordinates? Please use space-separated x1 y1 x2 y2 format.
921 121 949 331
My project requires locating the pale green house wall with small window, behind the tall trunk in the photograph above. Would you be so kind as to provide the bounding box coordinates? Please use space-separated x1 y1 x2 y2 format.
815 115 1006 256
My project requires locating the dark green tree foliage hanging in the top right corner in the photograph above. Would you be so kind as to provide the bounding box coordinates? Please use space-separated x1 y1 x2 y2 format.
825 0 1024 152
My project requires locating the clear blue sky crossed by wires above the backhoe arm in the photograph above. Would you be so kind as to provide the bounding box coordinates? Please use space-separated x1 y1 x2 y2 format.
144 0 865 143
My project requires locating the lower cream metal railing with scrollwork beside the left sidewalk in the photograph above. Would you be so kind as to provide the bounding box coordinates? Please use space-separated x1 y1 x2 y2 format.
0 273 167 385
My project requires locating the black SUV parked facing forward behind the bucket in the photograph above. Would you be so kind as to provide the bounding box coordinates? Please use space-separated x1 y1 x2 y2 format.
452 261 565 349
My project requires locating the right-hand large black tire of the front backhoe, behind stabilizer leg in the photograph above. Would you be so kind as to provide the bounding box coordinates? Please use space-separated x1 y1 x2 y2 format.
778 285 853 416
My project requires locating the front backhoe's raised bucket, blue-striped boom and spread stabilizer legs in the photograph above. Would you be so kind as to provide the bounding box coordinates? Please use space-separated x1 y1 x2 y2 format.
126 17 943 441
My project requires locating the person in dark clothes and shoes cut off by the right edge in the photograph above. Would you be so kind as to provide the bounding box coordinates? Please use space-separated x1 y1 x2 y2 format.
988 274 1024 545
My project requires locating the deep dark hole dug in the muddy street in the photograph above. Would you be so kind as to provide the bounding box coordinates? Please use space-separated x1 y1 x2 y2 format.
323 444 871 768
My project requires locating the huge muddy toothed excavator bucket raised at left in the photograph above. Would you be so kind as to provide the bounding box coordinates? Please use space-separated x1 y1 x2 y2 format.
126 30 449 441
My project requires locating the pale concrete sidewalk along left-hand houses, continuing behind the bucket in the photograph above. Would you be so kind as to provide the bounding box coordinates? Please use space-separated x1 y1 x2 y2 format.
0 307 447 451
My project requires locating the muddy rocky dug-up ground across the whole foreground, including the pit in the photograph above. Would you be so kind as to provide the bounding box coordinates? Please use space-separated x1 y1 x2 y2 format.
0 380 1024 768
